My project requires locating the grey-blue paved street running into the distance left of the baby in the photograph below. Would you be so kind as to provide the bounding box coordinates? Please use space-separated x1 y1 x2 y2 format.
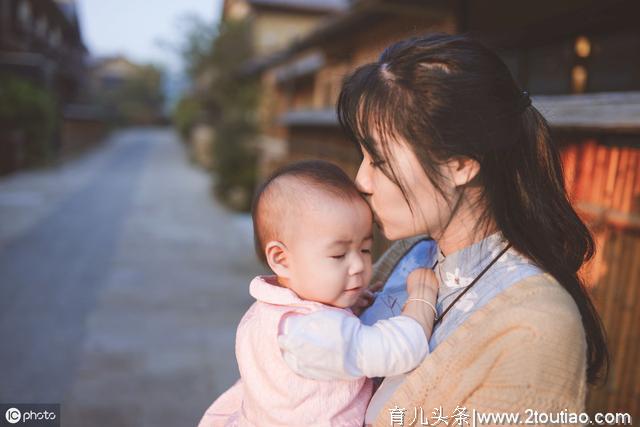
0 129 264 427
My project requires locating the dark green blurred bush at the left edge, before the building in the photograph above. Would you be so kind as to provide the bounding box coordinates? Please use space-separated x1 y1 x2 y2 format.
0 74 57 165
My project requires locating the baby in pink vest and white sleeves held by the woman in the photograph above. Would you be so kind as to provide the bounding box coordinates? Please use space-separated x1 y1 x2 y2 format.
199 161 437 427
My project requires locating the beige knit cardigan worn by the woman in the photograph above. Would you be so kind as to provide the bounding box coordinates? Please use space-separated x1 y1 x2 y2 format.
374 238 587 427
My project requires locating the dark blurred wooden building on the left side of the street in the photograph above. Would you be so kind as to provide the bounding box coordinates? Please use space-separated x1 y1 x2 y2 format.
0 0 104 174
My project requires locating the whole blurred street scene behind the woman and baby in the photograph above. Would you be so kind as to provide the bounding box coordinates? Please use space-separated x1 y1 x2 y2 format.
0 0 640 426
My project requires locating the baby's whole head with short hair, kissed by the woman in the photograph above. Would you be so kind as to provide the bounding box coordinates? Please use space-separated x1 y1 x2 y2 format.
252 160 373 308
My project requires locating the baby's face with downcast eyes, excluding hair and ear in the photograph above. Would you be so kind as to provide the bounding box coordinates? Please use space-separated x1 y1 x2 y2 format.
289 198 373 308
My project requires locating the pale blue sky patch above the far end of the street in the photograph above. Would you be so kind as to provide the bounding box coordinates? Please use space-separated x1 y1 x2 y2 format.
76 0 222 74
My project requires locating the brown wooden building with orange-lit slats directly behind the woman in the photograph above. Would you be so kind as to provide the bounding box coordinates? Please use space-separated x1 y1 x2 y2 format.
244 0 640 419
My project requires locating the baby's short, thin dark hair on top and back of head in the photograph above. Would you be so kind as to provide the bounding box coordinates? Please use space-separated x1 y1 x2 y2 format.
251 160 364 266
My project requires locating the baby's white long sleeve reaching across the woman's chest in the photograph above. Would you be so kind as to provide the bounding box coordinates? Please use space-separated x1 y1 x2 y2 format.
278 310 429 380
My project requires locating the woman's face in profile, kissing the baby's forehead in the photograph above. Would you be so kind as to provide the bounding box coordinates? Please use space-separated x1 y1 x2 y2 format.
356 133 451 240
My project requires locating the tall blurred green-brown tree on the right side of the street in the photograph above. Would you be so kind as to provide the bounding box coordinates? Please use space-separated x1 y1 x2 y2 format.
174 18 259 210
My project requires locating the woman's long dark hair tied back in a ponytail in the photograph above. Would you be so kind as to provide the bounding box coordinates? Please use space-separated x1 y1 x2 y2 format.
337 33 609 384
